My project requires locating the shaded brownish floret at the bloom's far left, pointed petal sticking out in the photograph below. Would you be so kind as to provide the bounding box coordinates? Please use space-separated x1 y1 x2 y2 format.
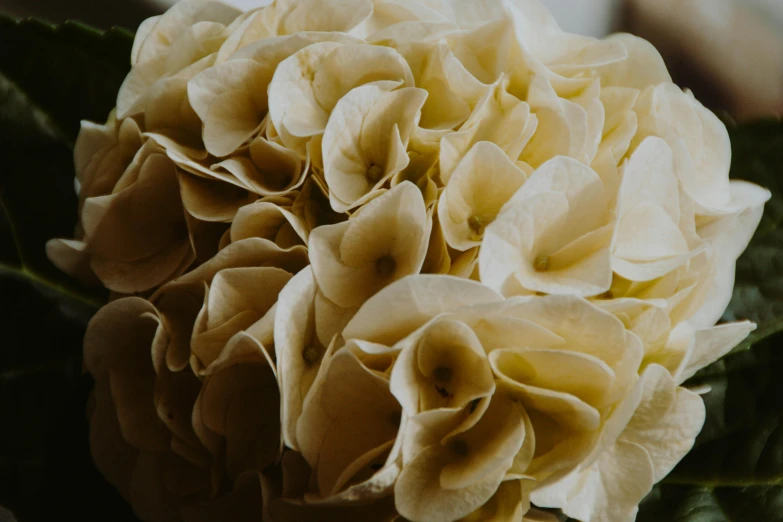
47 117 205 293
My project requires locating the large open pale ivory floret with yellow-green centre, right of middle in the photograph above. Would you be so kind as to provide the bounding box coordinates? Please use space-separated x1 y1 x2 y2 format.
479 157 614 296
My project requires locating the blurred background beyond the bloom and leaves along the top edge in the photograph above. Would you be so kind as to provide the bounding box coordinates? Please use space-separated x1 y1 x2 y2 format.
0 0 783 121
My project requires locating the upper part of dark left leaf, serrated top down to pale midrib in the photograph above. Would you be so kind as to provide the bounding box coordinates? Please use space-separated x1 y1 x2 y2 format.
0 16 133 305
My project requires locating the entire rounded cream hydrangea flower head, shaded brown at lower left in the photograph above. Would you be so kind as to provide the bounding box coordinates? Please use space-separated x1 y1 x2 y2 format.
47 0 769 522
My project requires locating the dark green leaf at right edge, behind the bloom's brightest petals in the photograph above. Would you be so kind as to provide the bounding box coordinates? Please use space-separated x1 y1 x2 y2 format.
724 121 783 351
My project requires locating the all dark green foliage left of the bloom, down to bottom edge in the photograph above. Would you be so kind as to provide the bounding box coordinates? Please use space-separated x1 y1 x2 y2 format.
0 18 135 522
